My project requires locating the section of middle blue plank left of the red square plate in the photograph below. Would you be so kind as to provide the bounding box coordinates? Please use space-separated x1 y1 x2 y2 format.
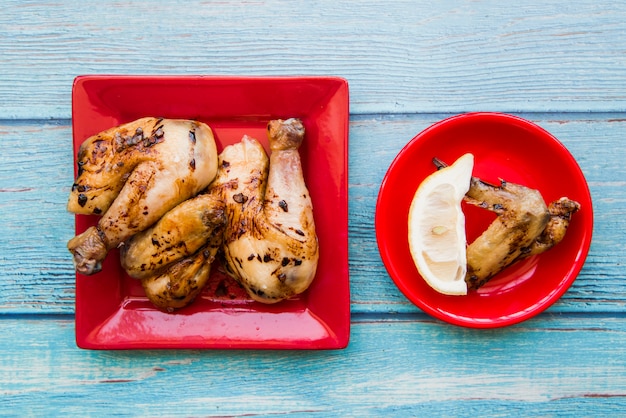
0 121 74 313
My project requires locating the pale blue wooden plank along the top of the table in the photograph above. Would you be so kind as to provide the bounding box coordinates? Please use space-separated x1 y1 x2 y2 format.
0 0 626 118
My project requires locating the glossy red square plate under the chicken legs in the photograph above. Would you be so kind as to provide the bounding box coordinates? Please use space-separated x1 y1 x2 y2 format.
72 75 350 349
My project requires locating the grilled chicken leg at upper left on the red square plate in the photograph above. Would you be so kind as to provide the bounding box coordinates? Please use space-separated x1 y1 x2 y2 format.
68 118 217 274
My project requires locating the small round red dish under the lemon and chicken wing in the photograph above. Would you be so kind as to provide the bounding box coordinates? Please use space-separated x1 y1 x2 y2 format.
375 112 593 328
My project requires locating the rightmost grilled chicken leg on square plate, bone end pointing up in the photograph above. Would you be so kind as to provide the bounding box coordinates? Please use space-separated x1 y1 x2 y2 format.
211 119 319 303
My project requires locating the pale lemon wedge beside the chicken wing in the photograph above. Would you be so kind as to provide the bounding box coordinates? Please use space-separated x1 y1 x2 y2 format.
409 154 474 295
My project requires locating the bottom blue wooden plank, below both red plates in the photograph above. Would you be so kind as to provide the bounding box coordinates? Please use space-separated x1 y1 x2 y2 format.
0 315 626 416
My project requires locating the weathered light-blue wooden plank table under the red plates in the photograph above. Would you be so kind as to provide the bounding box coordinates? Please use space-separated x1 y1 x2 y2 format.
0 0 626 416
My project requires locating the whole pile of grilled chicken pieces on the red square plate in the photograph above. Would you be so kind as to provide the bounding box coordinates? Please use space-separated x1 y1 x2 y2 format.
68 118 319 311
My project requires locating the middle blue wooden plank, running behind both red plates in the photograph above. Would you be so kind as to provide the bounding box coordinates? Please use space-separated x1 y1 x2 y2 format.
0 114 626 313
